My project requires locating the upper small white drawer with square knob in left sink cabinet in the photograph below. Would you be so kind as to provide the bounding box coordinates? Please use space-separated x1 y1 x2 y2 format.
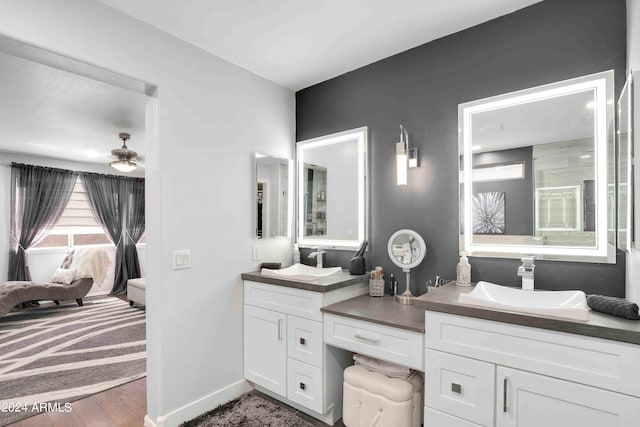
287 316 324 368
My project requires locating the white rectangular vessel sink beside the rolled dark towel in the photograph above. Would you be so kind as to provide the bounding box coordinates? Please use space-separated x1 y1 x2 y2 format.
458 282 589 320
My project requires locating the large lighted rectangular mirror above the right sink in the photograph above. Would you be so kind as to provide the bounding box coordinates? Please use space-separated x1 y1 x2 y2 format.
459 71 615 263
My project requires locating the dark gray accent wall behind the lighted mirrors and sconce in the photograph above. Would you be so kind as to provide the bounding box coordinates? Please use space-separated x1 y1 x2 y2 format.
296 0 626 296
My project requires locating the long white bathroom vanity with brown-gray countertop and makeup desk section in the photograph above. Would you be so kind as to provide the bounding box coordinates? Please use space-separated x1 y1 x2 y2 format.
242 266 640 427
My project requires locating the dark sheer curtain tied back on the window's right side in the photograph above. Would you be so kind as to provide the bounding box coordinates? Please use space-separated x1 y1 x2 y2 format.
80 173 145 294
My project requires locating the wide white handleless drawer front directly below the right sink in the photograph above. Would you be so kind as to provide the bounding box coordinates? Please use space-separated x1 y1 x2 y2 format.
425 311 640 397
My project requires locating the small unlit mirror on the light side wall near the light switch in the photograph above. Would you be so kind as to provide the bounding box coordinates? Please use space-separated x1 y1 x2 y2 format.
254 153 293 239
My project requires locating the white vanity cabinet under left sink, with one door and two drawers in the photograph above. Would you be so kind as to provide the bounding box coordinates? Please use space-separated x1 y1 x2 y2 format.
244 280 367 425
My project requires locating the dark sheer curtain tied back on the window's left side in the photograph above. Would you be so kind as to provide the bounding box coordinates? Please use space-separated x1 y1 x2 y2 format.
8 163 77 280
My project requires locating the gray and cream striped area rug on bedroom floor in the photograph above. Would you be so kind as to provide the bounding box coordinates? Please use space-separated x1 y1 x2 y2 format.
0 297 146 425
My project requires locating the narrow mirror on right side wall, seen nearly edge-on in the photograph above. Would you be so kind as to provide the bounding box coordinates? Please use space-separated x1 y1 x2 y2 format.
616 74 634 251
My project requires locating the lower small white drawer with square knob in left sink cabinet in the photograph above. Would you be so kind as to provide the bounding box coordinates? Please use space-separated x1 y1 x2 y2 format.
287 359 324 414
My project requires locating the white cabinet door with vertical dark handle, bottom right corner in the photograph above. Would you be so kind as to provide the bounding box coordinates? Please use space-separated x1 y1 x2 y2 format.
496 366 640 427
